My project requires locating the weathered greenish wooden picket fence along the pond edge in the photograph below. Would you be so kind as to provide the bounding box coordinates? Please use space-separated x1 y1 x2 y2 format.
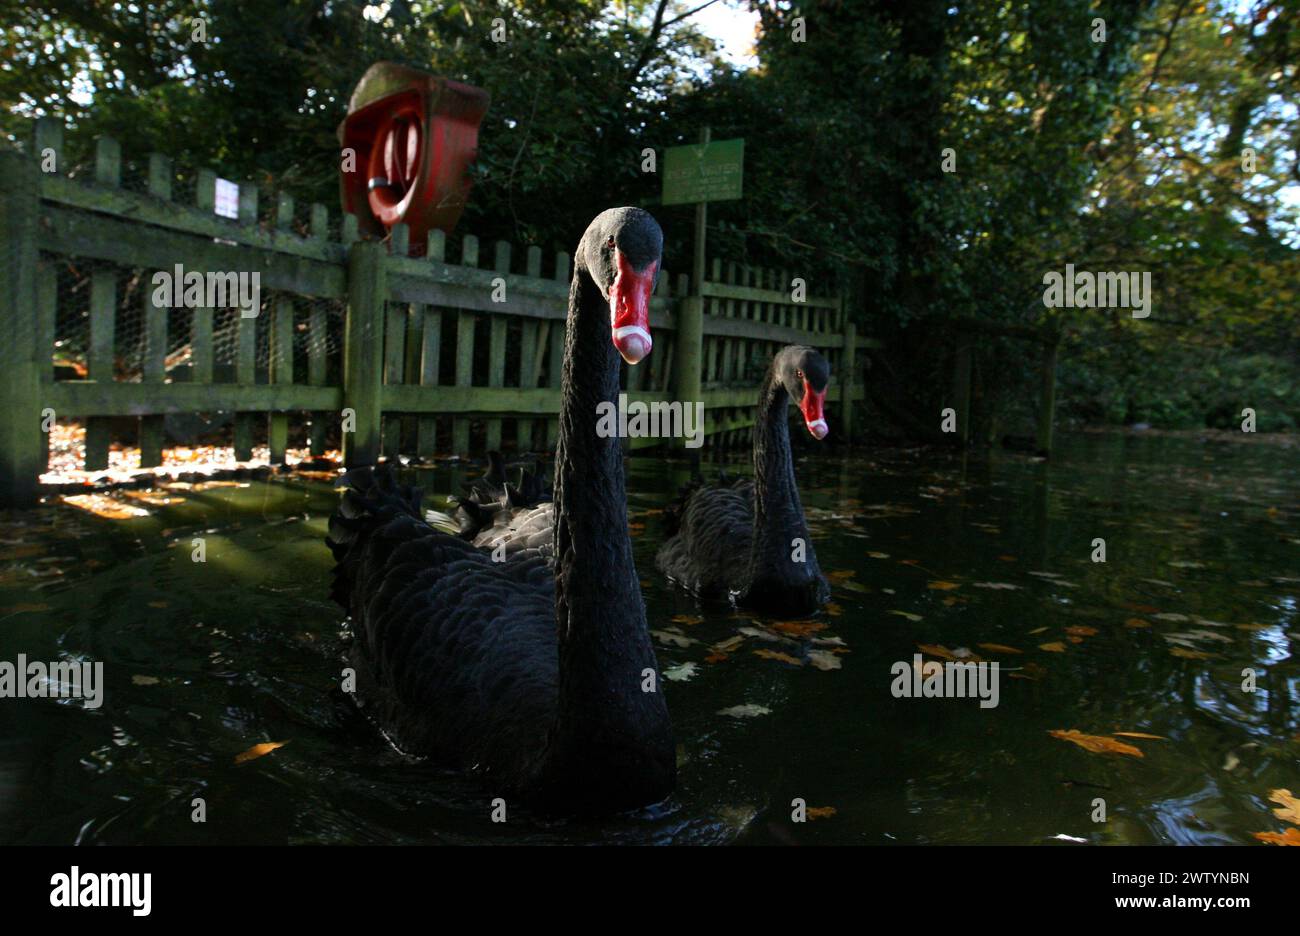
0 120 874 504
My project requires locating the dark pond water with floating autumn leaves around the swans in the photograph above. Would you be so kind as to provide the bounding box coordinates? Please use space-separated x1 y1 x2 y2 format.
0 434 1300 844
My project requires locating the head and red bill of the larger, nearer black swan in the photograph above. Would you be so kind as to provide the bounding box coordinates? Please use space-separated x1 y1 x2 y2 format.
579 208 663 364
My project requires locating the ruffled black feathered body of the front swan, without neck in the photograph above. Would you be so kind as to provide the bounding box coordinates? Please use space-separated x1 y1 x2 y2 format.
329 465 558 792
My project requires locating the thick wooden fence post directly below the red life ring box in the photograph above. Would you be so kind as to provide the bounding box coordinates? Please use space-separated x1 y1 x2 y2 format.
343 242 387 468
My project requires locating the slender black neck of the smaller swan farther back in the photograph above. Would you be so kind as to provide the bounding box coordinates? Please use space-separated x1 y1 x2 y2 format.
748 359 822 599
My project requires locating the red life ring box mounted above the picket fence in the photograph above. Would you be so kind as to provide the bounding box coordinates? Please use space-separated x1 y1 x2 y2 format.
338 62 490 255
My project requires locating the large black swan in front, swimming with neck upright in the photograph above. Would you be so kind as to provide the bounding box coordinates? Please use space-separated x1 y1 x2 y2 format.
329 208 676 814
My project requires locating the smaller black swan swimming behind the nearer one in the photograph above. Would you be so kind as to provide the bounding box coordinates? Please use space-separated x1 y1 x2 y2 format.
657 345 831 615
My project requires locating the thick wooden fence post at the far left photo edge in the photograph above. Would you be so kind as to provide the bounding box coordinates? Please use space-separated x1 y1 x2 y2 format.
0 152 43 507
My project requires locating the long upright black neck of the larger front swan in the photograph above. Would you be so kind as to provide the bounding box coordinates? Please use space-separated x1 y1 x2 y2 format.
542 268 676 809
